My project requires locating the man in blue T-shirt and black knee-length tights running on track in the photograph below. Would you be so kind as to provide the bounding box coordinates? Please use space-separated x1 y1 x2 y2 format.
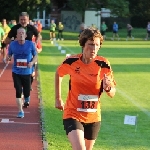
7 27 37 118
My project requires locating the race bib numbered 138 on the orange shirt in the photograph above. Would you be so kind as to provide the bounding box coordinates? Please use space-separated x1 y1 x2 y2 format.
77 94 98 112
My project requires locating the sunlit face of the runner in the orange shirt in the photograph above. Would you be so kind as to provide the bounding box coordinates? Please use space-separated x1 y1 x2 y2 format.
83 37 100 59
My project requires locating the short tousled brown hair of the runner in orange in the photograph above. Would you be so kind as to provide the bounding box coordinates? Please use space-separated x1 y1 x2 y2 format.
79 27 103 47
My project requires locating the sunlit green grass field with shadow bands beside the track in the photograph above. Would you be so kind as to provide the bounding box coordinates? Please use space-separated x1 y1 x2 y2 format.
38 29 150 150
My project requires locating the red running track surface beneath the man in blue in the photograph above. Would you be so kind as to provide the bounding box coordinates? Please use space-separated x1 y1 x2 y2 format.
0 57 43 150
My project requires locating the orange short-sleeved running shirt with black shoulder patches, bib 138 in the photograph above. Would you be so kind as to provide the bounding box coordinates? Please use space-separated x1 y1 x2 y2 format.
57 54 115 123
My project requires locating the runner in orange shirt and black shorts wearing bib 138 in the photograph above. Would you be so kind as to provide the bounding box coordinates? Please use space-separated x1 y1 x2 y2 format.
55 28 116 150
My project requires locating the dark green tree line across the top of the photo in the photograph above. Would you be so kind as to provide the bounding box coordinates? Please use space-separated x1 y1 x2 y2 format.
0 0 150 25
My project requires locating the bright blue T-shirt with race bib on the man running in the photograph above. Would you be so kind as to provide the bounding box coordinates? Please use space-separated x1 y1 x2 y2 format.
8 40 37 75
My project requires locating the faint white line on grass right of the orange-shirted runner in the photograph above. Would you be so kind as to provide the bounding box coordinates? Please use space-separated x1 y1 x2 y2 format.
117 88 150 117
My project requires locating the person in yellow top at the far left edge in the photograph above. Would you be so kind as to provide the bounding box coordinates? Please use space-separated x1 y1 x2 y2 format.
1 19 10 63
